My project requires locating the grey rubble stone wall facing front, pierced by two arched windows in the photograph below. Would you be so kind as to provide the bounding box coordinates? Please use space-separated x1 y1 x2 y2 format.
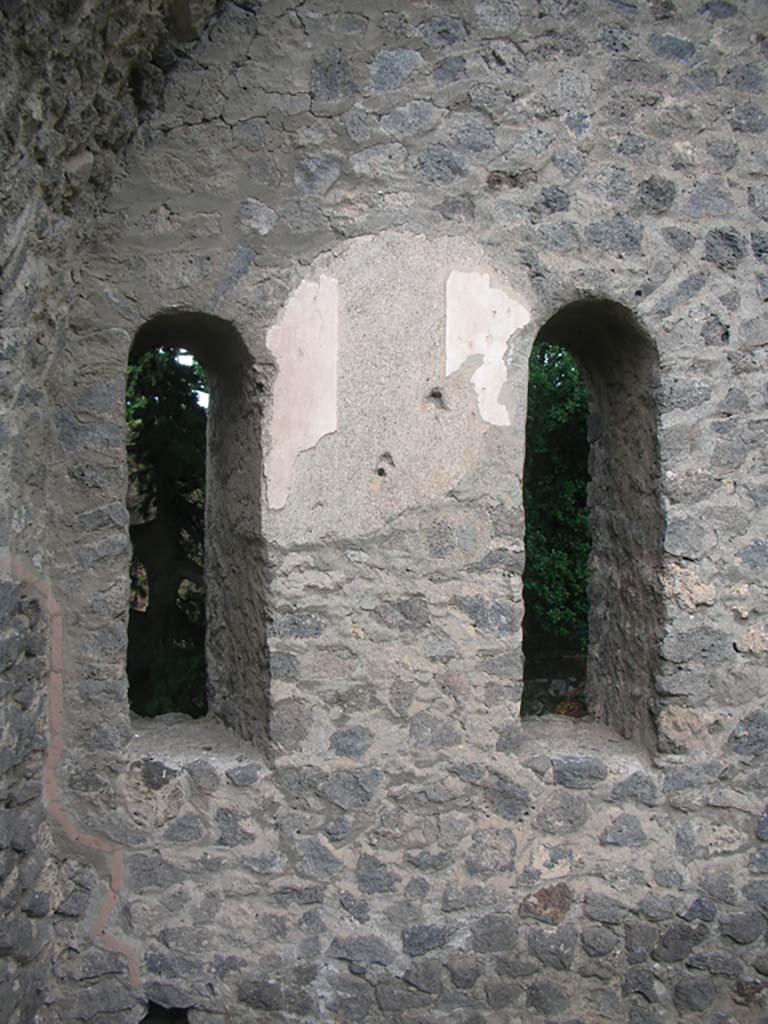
1 0 768 1024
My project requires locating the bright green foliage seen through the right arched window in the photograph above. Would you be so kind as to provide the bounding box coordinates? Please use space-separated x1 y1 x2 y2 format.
523 345 591 657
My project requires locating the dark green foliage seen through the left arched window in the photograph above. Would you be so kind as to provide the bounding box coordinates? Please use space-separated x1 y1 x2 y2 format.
126 349 208 717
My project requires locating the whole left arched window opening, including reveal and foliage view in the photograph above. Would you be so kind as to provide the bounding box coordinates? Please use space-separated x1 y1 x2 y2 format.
127 310 269 751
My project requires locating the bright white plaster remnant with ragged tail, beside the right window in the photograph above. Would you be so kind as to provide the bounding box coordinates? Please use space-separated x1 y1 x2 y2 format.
445 270 530 427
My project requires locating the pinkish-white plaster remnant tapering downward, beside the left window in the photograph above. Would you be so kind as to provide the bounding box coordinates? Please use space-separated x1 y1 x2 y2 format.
264 274 339 509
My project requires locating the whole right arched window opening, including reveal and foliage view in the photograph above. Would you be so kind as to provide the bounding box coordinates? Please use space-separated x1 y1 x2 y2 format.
523 298 664 746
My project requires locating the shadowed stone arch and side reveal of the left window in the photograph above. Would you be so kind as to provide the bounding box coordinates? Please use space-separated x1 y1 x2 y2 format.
129 310 269 750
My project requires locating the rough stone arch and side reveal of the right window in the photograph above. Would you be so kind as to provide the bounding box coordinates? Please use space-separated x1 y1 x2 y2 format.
523 299 664 745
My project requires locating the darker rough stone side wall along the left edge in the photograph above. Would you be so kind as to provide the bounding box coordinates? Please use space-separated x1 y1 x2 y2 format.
0 0 218 1024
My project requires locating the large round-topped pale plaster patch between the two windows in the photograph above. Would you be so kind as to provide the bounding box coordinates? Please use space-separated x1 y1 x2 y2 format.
265 231 529 543
